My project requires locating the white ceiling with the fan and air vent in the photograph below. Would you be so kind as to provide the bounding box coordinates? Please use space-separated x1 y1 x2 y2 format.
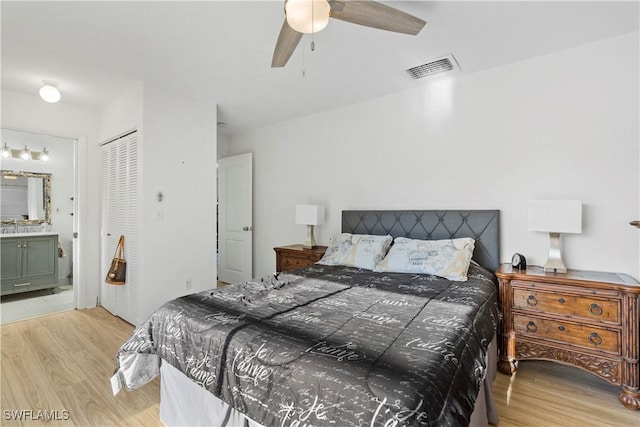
1 0 640 133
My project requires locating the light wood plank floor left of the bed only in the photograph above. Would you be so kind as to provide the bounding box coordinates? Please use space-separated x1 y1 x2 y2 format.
0 308 162 427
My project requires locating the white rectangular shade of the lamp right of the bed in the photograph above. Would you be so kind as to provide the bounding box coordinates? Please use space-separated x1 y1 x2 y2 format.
529 200 582 233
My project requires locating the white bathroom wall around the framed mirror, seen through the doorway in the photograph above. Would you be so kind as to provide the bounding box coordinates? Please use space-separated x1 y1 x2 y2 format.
2 129 75 285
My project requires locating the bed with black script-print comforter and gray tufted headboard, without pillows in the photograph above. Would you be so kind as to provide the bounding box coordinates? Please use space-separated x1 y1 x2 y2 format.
116 211 500 426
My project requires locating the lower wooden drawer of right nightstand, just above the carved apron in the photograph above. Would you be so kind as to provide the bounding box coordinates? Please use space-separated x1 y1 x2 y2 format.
513 314 620 354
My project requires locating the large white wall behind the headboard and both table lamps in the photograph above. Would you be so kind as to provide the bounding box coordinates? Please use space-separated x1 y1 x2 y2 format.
229 32 640 278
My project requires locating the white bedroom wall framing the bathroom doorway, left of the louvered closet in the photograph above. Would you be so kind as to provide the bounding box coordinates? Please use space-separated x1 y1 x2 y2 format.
1 89 100 308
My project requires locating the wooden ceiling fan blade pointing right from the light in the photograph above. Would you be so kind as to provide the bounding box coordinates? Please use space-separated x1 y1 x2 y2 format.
329 0 426 36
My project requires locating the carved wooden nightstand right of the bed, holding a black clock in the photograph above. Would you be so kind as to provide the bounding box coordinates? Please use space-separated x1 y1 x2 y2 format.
496 264 640 410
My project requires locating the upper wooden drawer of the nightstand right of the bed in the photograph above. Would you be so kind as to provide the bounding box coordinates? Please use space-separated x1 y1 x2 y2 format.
513 287 620 325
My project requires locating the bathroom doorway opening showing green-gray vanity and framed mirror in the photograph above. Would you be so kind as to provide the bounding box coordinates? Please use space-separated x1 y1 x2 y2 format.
0 129 79 324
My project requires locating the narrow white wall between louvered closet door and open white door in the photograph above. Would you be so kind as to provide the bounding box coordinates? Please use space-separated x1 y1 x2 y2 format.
141 86 217 319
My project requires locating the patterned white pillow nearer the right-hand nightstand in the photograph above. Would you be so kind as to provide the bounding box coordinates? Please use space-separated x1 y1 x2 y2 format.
375 237 475 282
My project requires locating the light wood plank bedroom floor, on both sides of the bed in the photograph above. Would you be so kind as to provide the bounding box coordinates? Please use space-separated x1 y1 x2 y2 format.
0 308 640 427
